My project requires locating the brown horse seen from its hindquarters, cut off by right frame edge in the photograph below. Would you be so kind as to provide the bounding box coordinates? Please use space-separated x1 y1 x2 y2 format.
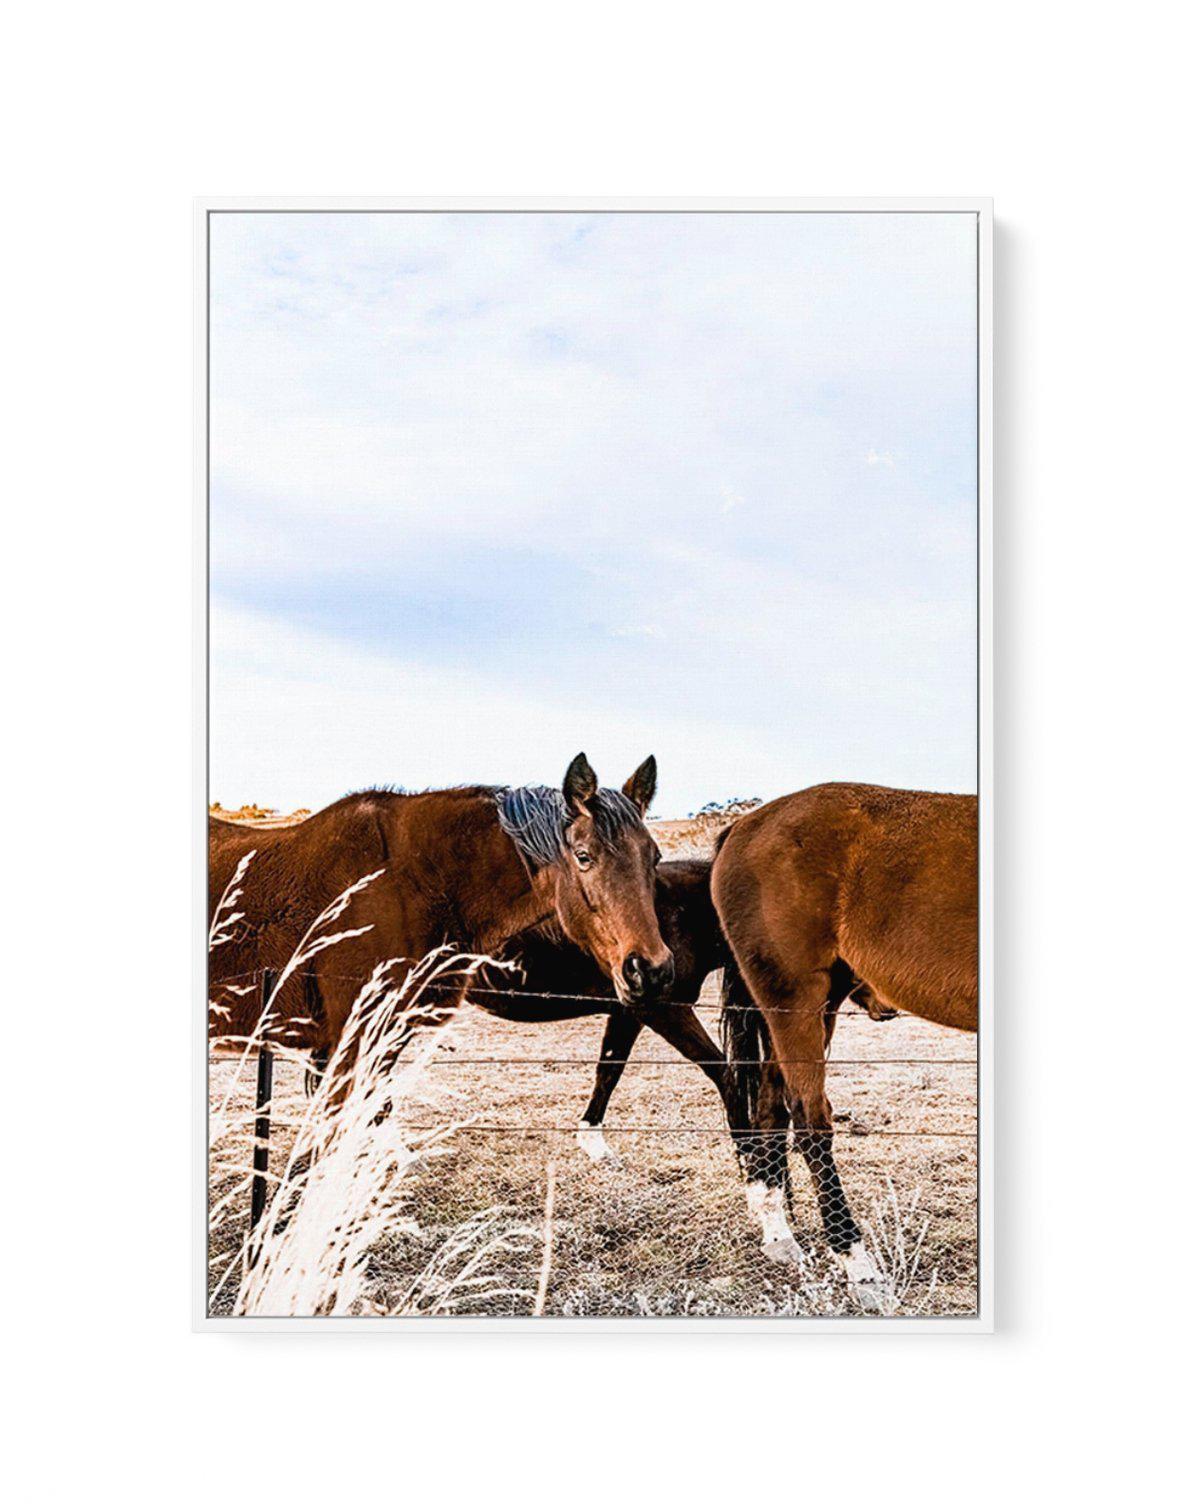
712 782 979 1302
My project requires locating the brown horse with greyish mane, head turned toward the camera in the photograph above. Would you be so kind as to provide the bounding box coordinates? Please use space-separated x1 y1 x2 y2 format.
209 753 674 1057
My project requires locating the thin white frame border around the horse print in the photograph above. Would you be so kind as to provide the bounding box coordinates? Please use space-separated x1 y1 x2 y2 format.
190 195 996 1335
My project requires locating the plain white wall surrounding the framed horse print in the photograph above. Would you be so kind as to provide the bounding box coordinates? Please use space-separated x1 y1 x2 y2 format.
3 0 1195 1509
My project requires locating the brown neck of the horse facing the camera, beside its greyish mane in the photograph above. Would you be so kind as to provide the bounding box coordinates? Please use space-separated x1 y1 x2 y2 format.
435 798 555 951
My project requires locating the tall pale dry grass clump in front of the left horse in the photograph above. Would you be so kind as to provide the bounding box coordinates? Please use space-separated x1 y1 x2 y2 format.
209 854 527 1317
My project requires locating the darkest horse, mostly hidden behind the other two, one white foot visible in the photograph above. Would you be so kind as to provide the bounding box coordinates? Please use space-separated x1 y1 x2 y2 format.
470 860 733 1161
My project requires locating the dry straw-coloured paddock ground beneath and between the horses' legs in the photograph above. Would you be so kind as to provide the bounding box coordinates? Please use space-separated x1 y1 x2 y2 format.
210 821 976 1317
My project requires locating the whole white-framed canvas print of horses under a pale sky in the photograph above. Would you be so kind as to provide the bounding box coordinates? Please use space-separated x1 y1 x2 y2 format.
193 200 993 1332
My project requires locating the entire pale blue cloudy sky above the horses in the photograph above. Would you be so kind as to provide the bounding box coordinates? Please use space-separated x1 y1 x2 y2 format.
210 213 976 816
